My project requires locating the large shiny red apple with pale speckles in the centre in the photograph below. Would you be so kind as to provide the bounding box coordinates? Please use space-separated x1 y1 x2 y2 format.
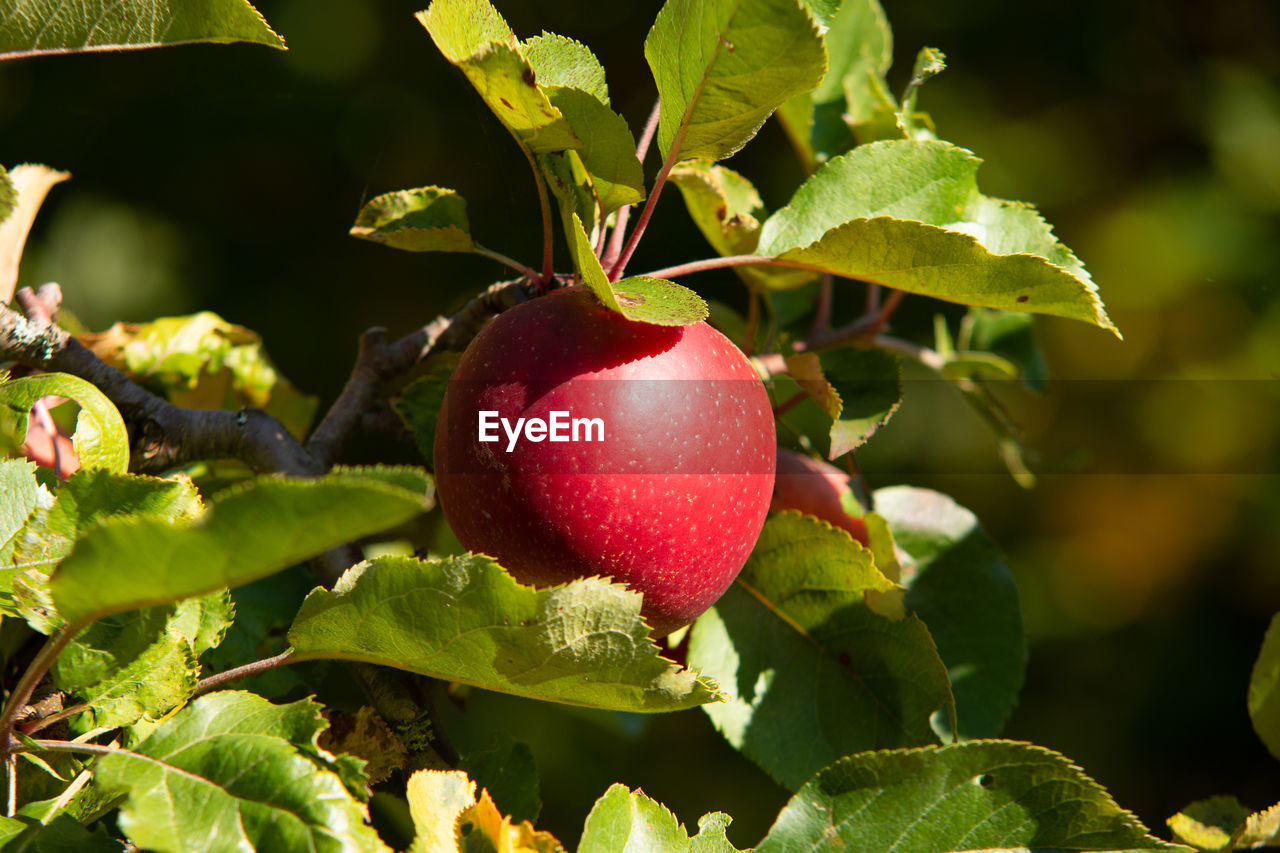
434 289 777 637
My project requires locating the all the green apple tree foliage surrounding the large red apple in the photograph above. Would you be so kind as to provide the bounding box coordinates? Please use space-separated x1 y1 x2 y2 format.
0 0 1264 853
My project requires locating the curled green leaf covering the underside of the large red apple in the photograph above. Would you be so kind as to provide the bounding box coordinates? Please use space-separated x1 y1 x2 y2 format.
289 555 718 711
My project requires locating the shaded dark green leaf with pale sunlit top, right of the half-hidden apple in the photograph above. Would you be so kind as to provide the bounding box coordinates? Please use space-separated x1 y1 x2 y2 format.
874 485 1027 738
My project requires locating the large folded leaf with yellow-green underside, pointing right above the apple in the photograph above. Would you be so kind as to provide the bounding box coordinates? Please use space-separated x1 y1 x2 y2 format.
759 140 1119 334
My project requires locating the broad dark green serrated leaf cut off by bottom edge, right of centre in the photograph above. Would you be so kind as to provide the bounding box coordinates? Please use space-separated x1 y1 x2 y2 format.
755 740 1185 853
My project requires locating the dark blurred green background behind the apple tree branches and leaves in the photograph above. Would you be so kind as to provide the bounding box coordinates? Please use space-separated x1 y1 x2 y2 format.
0 0 1280 844
